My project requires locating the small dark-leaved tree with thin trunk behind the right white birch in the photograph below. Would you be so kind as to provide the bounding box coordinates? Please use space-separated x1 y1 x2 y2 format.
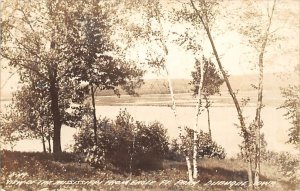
190 57 224 139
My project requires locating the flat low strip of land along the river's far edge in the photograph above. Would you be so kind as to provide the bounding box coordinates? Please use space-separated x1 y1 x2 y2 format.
90 90 283 107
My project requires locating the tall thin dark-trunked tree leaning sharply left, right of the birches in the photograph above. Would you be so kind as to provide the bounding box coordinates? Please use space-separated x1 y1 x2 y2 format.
180 0 253 188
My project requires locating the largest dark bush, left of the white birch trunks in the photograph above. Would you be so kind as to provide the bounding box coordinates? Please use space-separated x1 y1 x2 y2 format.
74 110 168 171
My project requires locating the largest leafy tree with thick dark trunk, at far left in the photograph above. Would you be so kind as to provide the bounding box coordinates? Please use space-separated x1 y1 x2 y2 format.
1 0 142 153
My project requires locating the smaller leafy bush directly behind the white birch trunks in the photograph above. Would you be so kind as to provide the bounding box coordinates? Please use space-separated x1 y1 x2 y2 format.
168 127 226 161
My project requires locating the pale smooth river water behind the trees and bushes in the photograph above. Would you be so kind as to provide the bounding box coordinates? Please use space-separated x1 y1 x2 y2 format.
1 101 293 156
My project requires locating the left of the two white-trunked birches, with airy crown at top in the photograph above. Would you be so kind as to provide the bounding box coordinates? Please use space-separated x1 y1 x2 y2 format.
119 0 193 181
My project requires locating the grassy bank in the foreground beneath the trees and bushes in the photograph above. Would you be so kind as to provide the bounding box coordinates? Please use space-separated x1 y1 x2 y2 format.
1 151 293 191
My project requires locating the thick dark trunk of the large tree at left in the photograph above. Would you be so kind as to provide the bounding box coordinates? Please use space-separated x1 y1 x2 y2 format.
50 80 62 154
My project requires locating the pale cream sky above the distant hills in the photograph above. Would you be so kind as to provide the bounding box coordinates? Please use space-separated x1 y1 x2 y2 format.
0 0 300 96
